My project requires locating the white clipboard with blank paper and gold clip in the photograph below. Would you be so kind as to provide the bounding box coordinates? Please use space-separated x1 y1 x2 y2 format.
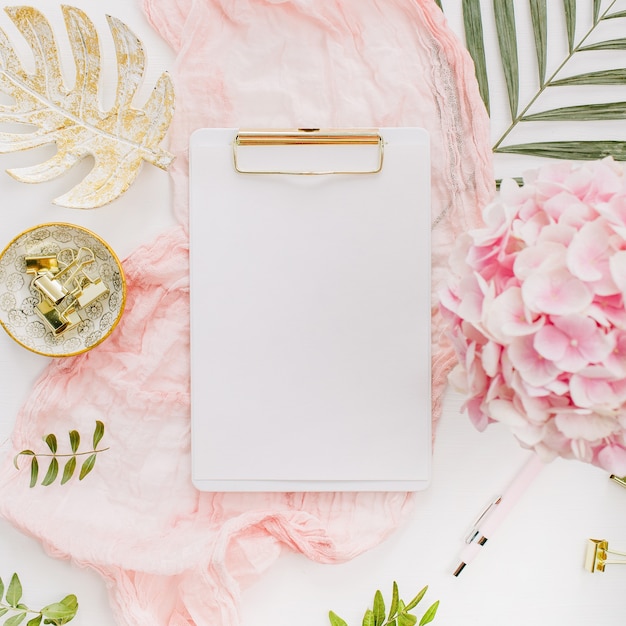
189 128 432 492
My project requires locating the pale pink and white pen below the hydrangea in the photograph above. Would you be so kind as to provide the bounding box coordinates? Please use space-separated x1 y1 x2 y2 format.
454 453 545 576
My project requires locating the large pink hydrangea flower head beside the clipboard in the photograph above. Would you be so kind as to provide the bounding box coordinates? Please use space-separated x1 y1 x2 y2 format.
440 158 626 476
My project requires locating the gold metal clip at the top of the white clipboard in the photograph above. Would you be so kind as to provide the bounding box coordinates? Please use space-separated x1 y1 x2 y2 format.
233 128 384 176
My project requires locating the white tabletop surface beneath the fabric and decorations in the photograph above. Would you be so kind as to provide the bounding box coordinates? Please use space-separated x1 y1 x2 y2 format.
0 0 626 626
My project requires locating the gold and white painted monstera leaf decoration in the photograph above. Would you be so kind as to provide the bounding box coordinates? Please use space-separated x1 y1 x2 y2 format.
0 6 174 209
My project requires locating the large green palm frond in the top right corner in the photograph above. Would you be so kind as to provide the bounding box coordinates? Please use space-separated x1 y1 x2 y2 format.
436 0 626 161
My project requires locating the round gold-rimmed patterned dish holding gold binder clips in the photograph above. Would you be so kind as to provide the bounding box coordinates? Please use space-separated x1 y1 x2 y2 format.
0 223 126 357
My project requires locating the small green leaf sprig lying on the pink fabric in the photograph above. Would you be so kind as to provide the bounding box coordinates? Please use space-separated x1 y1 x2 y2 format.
13 420 109 488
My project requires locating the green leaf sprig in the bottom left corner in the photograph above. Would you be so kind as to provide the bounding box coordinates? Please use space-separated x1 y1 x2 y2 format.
0 574 78 626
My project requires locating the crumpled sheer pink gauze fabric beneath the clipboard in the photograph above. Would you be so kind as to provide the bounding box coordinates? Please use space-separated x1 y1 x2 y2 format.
0 0 493 626
